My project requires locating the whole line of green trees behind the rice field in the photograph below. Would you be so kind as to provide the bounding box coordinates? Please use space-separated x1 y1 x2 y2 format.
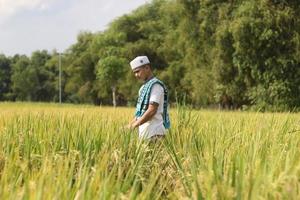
0 0 300 111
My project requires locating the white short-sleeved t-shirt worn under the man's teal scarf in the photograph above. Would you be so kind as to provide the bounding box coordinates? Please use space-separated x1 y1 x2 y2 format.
139 83 166 139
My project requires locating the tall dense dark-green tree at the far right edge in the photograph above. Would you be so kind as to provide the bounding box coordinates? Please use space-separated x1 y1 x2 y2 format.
230 1 300 110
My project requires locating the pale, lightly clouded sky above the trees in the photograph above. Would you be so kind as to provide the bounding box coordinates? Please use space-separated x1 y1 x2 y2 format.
0 0 149 56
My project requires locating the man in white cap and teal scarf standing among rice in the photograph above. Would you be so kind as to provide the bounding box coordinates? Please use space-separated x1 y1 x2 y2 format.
128 56 170 139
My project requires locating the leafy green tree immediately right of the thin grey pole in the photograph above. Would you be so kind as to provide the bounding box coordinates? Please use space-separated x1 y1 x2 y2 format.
62 32 99 103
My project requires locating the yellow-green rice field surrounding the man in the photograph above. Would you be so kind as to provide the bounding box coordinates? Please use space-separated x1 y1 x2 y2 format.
0 103 300 199
